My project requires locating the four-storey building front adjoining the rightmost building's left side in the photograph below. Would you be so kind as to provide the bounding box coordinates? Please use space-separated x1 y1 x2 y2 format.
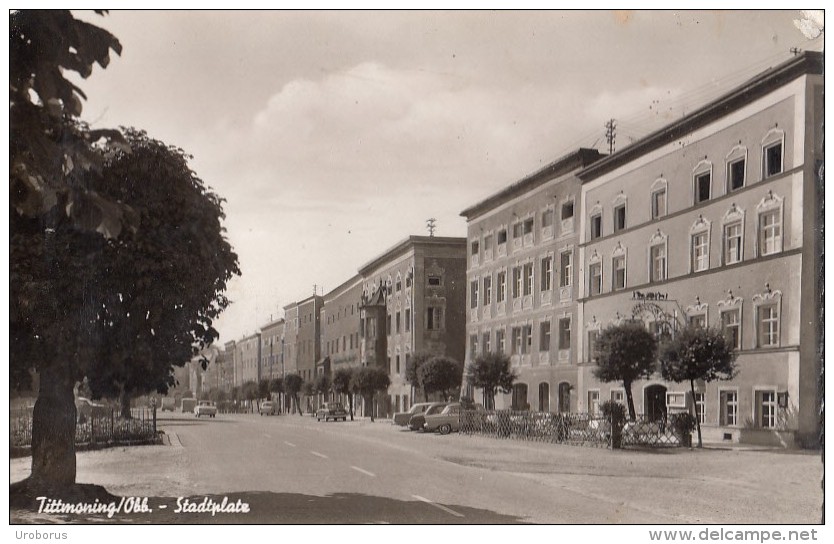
461 149 601 412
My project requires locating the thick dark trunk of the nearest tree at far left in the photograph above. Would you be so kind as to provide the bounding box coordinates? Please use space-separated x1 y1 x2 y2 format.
30 368 76 486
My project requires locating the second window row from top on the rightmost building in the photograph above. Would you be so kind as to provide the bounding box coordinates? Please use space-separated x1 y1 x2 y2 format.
587 193 783 296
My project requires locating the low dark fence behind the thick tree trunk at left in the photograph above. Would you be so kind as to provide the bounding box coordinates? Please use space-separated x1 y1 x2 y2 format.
9 407 157 448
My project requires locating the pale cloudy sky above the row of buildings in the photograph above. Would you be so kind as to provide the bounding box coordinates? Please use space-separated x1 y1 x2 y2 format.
68 11 822 343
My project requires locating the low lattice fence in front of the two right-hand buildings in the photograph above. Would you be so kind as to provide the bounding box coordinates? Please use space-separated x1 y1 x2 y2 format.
460 410 682 448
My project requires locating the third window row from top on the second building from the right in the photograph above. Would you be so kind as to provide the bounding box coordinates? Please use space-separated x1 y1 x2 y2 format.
469 316 571 360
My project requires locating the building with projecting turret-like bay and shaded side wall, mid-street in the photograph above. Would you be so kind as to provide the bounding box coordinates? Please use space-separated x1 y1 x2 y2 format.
359 236 466 417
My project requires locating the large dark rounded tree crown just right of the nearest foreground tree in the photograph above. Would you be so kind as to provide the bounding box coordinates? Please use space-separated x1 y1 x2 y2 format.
71 129 239 412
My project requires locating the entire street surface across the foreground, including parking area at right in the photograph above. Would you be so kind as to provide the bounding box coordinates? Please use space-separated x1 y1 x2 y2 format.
12 413 822 524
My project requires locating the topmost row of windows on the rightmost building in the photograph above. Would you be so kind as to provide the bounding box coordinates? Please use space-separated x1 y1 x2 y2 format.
588 130 784 240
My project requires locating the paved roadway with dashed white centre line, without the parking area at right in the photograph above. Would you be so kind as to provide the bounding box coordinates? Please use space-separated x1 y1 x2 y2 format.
161 415 632 524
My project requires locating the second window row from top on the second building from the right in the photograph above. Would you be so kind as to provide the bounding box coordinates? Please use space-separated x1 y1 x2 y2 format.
469 249 573 309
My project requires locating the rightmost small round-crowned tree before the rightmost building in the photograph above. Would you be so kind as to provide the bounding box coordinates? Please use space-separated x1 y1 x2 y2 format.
660 325 736 448
